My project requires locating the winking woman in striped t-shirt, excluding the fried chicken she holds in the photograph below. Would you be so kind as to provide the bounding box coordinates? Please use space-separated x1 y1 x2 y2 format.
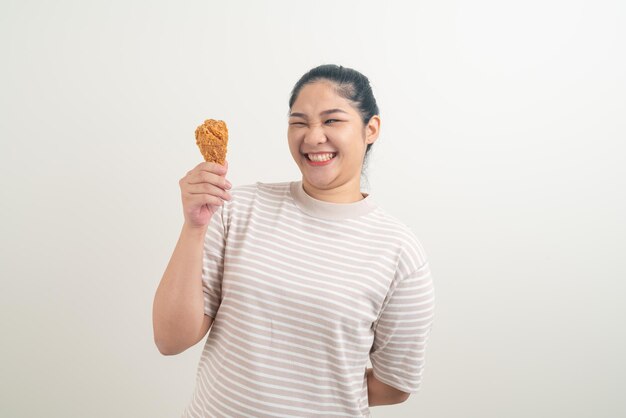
154 65 434 417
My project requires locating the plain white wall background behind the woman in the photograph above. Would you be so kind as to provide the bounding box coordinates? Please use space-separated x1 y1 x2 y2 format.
0 0 626 418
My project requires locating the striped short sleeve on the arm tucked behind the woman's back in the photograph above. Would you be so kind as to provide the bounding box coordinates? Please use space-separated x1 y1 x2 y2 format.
370 262 435 393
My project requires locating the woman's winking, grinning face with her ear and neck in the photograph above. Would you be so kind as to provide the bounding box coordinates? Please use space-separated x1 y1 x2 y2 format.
287 81 380 203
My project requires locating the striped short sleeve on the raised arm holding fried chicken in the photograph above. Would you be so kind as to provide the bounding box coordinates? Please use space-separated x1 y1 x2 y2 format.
202 206 226 318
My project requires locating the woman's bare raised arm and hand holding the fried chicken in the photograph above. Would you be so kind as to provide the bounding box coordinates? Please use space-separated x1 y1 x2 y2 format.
152 163 231 355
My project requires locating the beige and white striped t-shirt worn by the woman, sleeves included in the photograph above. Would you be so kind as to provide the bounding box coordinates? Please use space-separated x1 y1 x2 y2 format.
183 181 434 418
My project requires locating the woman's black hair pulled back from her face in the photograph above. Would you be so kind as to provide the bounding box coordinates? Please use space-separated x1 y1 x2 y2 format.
289 64 379 178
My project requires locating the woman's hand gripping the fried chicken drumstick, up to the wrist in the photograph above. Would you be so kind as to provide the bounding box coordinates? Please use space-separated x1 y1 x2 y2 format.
178 161 232 228
